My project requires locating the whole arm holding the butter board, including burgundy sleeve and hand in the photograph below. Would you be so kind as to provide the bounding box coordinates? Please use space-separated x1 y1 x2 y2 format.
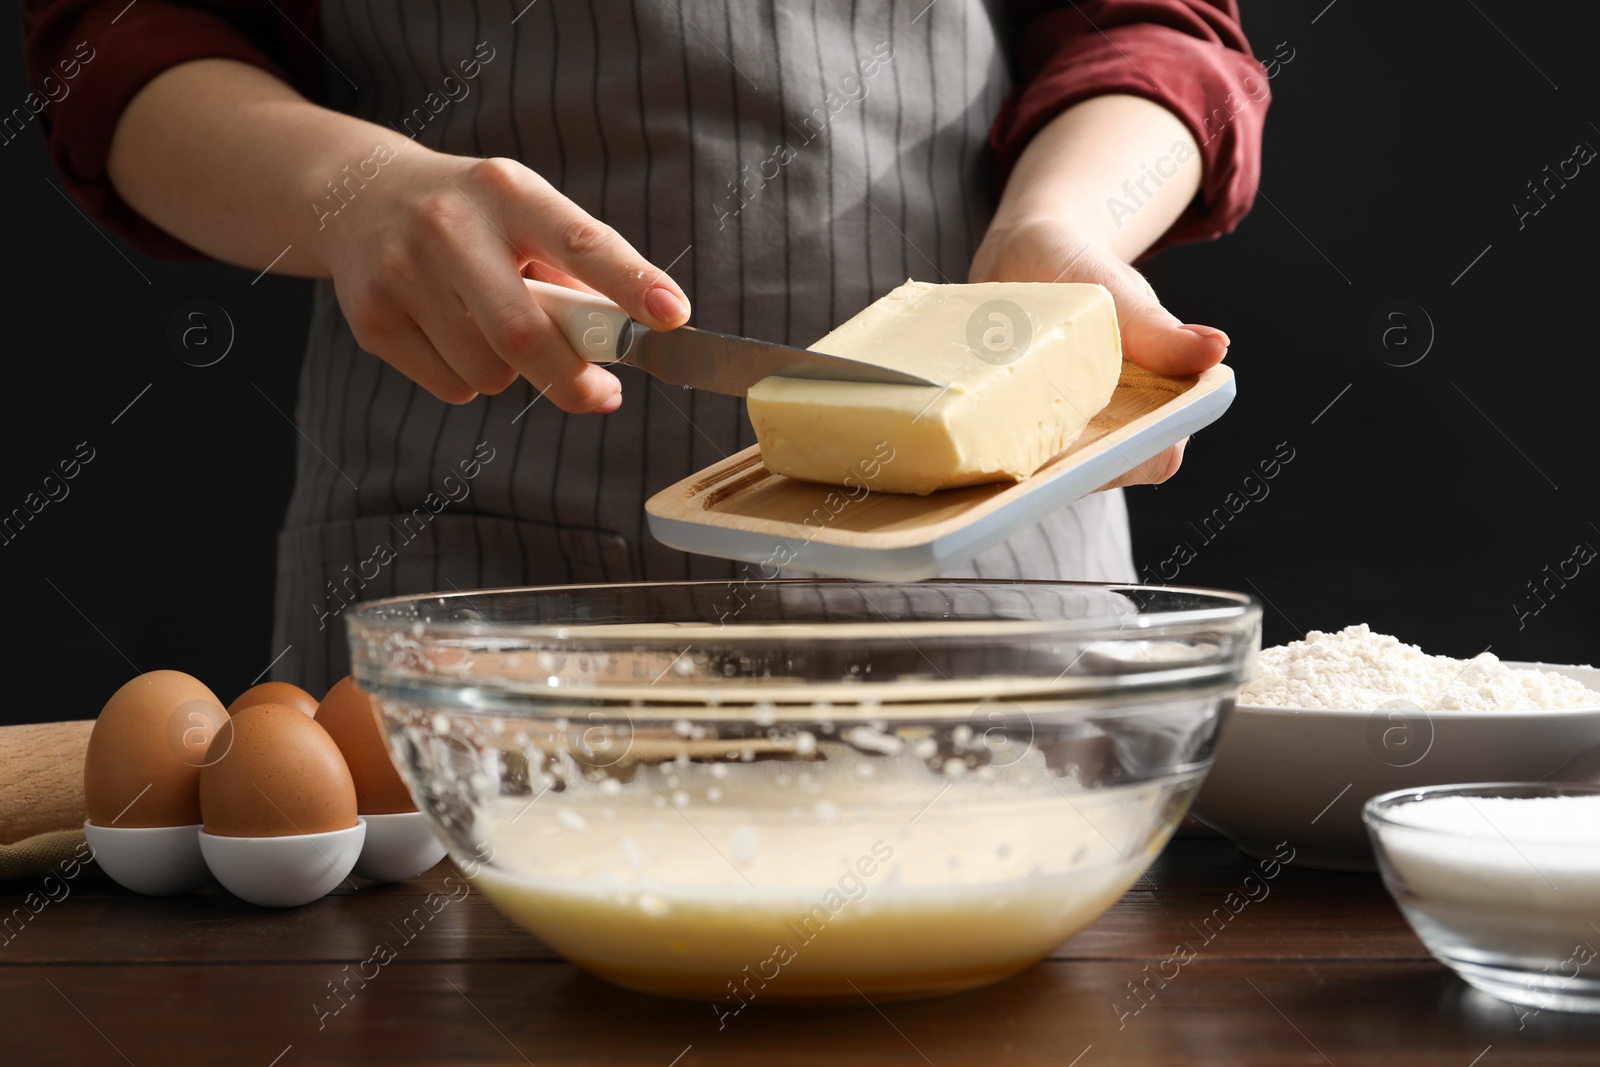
970 0 1270 488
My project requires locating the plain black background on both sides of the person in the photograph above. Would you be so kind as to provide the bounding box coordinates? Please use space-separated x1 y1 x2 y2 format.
0 0 1600 721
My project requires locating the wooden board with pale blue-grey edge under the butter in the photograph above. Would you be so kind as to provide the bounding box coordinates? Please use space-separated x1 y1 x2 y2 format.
645 362 1235 581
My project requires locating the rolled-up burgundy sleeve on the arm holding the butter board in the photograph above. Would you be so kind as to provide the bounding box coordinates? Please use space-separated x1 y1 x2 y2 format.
990 0 1270 253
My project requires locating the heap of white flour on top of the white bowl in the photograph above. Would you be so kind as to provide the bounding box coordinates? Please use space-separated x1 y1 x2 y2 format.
1238 622 1600 712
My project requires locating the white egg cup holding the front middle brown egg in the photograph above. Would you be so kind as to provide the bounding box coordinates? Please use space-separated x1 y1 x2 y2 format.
200 819 366 907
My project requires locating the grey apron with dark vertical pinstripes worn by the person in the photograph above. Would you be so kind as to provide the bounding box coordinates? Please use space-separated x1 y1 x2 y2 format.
274 0 1134 693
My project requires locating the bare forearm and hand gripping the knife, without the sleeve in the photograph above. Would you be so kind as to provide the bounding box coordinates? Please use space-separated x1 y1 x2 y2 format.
109 59 688 413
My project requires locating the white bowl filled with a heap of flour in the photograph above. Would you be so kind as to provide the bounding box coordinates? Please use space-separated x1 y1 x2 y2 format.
1194 624 1600 870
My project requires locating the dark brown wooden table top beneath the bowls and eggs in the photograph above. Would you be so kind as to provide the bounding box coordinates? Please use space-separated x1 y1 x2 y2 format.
0 838 1600 1067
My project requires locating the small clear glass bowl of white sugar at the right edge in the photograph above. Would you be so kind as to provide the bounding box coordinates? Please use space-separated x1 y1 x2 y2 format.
1363 782 1600 1013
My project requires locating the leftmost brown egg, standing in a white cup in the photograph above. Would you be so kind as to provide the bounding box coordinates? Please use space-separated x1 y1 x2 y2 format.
83 670 227 827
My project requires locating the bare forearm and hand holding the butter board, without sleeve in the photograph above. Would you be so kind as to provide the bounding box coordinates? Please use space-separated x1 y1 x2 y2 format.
968 96 1227 490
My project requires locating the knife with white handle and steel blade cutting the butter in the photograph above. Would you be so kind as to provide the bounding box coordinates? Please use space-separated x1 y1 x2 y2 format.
525 278 939 397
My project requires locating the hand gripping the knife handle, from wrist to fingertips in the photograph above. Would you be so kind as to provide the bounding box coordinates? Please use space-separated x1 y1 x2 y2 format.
323 144 690 413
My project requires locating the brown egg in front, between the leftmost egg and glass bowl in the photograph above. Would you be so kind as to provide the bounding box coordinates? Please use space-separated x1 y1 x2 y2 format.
200 704 355 837
